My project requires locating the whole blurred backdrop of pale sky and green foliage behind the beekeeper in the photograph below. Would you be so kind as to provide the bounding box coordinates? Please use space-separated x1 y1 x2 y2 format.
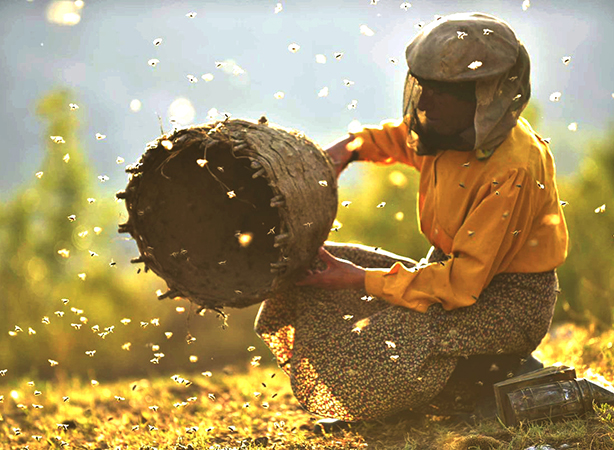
0 0 614 383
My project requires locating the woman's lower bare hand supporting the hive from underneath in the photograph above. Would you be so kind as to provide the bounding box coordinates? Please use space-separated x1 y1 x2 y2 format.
296 247 365 290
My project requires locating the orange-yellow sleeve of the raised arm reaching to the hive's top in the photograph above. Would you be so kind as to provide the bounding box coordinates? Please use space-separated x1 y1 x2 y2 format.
350 120 421 170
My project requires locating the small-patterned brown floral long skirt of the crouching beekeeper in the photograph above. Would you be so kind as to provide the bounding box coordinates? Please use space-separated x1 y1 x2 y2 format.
255 243 558 421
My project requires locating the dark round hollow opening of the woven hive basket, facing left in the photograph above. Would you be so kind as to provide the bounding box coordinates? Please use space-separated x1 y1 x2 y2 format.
134 135 280 299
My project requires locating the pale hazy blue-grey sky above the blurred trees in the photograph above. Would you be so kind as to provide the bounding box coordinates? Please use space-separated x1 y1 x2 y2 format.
0 0 614 197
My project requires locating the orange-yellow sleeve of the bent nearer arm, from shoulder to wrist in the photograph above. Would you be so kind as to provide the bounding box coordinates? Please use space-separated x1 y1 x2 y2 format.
365 169 537 312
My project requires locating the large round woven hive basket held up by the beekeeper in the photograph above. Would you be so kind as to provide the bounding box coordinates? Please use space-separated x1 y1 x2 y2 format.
117 118 337 308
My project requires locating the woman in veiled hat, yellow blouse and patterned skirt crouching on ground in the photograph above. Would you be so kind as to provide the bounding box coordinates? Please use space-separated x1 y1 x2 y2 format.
255 10 568 421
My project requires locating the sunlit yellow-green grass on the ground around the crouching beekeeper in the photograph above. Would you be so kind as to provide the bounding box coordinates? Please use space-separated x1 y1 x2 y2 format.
0 325 614 450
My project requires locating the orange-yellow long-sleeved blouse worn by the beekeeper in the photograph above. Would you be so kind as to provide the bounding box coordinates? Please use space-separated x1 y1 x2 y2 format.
352 118 568 312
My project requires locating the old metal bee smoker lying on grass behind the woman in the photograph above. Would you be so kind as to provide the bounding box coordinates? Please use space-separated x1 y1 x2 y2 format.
494 366 614 426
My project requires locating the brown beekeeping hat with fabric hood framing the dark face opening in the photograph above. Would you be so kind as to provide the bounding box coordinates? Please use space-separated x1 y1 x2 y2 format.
403 13 531 159
